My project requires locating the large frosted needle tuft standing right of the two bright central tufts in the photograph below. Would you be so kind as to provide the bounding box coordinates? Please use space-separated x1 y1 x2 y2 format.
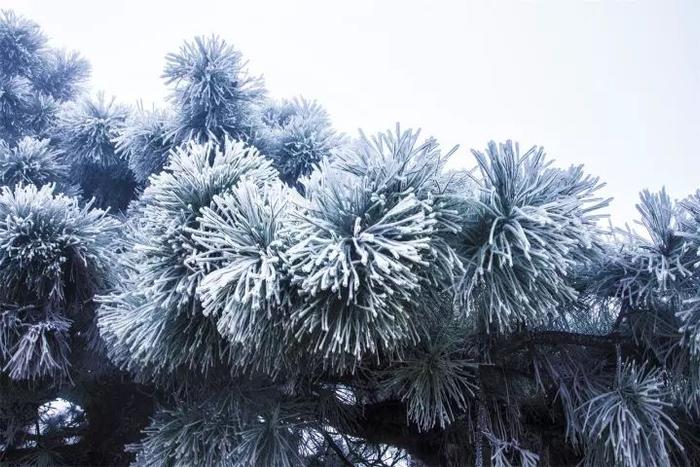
456 141 608 330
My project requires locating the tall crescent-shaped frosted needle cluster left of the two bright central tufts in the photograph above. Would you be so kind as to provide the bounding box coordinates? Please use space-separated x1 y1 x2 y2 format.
100 139 277 374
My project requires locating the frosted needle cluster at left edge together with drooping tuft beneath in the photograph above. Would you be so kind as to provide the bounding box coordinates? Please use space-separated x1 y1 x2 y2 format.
0 185 118 379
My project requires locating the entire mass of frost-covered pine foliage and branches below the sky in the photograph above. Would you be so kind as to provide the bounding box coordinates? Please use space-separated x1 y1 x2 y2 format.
0 8 700 467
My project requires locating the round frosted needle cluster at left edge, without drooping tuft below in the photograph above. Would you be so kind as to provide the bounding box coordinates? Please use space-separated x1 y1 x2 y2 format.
0 185 118 307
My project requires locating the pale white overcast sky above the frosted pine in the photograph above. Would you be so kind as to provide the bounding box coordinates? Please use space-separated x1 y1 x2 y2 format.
6 0 700 224
